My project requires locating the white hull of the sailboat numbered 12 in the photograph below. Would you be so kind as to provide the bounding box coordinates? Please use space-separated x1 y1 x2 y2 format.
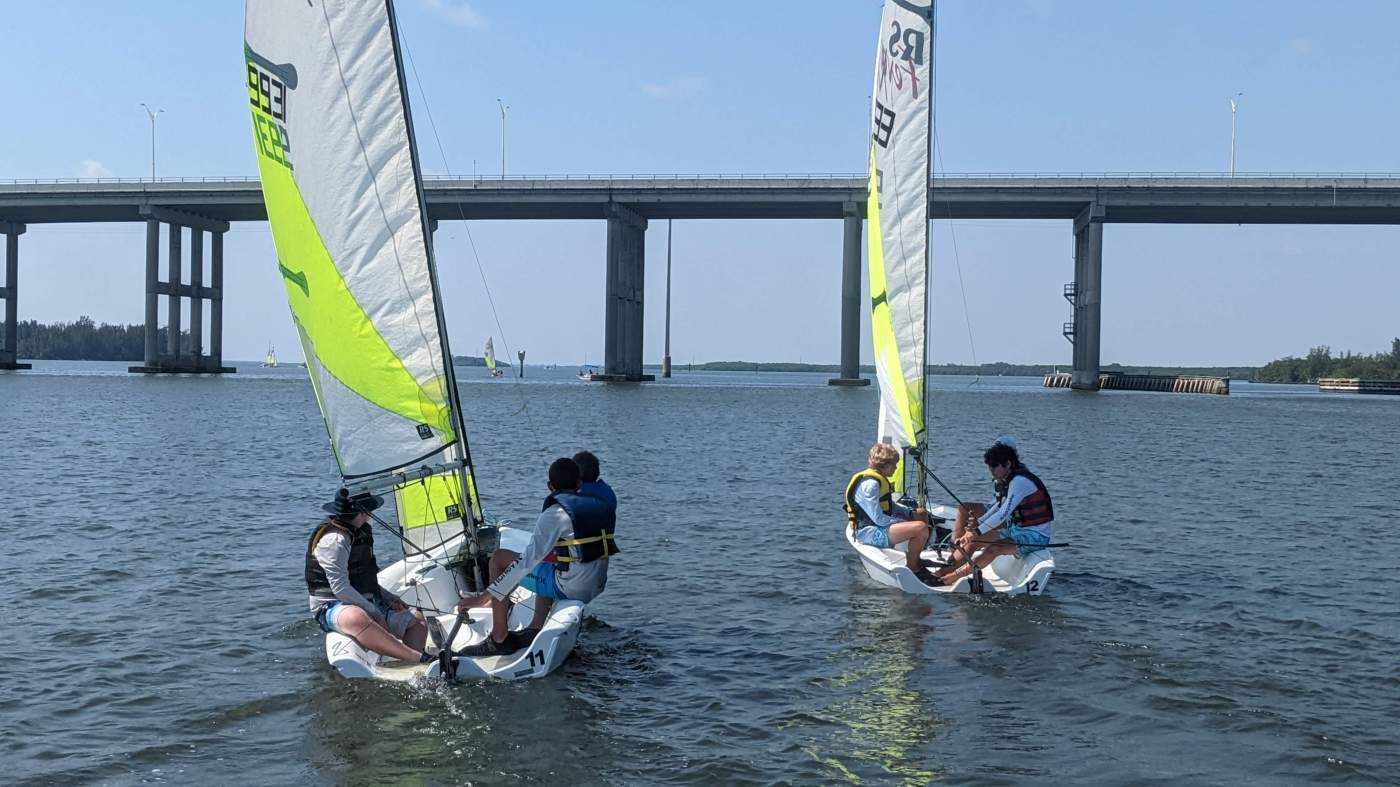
844 506 1054 595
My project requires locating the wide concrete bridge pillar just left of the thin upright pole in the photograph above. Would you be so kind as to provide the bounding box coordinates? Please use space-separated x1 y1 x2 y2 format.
592 203 655 382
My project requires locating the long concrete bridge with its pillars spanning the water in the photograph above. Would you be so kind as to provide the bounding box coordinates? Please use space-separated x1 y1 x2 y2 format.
0 174 1400 389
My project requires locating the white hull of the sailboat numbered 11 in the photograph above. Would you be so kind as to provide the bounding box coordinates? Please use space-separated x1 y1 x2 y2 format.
325 528 585 681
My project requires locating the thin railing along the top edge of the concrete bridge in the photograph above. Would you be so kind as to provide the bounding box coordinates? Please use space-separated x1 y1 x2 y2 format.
8 169 1400 186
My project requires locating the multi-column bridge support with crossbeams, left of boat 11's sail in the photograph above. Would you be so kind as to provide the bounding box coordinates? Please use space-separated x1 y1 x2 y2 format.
127 207 237 374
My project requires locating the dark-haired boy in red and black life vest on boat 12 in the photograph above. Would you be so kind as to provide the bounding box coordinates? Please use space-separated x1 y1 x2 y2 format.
934 438 1054 585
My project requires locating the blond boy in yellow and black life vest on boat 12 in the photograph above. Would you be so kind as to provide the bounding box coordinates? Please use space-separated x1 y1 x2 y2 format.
844 443 934 583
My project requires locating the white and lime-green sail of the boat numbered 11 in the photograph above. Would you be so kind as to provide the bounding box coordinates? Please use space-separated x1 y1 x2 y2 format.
244 0 479 548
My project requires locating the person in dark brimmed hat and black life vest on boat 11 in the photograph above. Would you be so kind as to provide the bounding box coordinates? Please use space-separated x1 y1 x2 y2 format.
305 487 433 662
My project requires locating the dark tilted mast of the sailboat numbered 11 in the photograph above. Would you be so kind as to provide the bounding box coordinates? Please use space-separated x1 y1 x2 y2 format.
384 0 486 591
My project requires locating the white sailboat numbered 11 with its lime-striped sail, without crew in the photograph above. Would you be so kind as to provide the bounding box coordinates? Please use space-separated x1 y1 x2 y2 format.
244 0 582 679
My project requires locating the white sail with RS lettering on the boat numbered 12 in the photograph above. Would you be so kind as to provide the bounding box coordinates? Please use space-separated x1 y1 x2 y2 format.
867 0 934 486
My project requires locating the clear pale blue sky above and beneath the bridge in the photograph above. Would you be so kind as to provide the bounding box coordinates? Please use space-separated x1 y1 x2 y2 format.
0 0 1400 364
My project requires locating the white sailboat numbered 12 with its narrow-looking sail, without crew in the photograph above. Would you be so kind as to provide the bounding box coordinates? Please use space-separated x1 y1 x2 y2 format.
844 0 1054 595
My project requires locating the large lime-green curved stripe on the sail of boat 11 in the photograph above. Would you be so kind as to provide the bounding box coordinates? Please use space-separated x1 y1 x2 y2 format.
252 108 455 443
